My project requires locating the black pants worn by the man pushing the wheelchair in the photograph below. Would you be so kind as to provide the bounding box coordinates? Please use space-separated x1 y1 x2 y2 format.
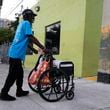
2 58 24 93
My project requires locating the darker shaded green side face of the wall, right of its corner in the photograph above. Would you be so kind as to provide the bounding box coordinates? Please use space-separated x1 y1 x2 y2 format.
82 0 103 76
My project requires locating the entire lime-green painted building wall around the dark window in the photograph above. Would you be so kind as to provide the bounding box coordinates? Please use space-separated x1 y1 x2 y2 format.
26 0 103 77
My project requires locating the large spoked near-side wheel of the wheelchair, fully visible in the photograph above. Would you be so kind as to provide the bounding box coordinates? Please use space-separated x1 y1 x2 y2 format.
38 68 68 102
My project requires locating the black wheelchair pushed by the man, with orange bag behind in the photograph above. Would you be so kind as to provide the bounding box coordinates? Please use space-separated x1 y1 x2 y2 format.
28 53 74 102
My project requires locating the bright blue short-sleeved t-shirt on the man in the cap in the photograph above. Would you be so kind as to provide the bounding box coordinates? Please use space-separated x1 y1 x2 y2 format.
8 20 32 60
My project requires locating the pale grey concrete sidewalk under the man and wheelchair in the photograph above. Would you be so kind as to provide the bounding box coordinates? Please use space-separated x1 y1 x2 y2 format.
0 64 110 110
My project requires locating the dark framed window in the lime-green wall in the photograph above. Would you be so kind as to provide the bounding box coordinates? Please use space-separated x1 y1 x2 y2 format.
45 21 61 54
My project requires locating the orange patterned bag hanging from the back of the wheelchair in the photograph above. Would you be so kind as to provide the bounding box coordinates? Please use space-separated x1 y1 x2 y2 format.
29 60 50 85
